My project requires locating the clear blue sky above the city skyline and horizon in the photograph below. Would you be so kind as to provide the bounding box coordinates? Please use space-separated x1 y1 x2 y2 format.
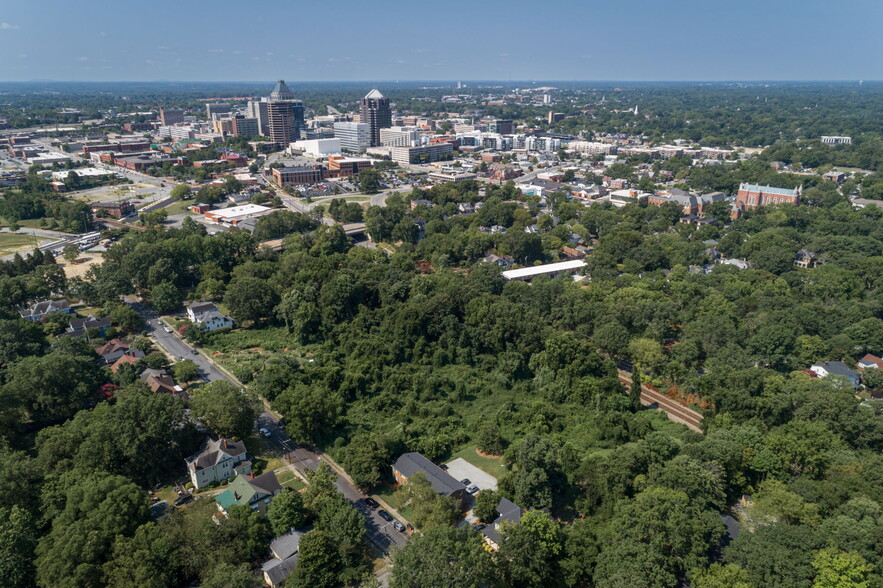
0 0 883 82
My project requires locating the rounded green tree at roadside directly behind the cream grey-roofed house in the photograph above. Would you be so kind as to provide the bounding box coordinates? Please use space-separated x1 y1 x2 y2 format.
191 380 260 438
